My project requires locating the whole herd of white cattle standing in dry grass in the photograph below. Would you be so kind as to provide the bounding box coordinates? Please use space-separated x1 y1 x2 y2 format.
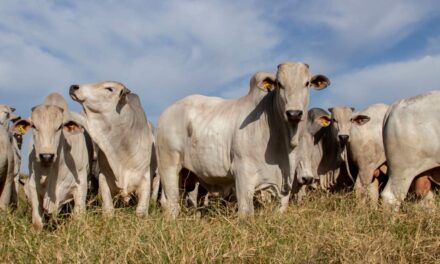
0 62 440 229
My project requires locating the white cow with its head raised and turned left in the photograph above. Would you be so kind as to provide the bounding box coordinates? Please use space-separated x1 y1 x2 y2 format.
70 81 156 216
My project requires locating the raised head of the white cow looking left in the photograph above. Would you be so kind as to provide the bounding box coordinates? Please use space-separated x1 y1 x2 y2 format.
69 81 130 113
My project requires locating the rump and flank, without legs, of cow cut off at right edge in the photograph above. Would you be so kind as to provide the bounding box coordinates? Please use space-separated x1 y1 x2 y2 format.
383 91 440 170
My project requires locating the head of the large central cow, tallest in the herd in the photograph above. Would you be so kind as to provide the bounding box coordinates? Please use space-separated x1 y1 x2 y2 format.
276 62 330 124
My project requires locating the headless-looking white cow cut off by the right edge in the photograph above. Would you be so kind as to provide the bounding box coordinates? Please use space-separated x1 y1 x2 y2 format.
381 91 440 210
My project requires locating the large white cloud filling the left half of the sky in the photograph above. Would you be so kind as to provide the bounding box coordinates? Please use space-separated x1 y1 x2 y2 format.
0 1 280 115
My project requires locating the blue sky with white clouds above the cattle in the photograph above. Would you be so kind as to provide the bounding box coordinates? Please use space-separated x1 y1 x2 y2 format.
0 0 440 171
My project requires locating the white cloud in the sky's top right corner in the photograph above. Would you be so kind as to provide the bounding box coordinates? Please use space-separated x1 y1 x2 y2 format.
280 0 440 61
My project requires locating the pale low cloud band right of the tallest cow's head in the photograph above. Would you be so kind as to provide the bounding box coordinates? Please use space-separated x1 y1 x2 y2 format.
318 55 440 110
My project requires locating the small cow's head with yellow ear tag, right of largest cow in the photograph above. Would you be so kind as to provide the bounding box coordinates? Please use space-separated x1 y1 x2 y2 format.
316 106 370 147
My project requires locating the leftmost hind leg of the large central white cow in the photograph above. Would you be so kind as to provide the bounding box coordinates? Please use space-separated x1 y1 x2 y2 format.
158 151 182 219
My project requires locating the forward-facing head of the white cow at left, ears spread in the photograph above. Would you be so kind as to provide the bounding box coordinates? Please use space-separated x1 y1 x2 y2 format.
13 105 83 164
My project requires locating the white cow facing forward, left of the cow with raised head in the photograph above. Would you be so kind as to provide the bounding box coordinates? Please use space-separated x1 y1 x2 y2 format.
14 93 92 229
